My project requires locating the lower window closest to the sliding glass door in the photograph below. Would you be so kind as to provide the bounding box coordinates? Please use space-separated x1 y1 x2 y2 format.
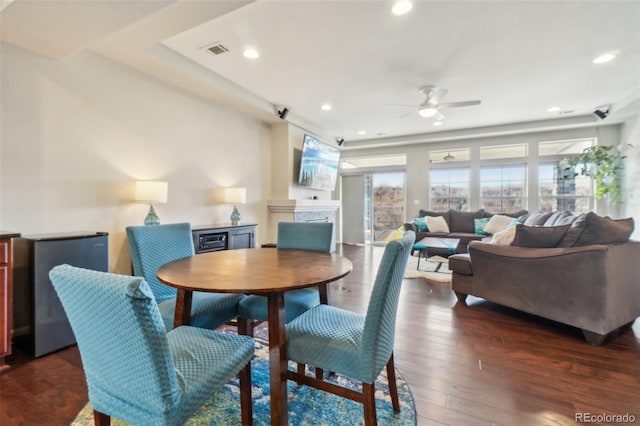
429 167 469 211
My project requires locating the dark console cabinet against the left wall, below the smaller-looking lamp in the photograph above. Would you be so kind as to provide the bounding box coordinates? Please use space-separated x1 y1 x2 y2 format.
191 223 258 254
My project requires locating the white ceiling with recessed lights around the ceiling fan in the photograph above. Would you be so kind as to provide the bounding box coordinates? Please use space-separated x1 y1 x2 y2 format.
0 0 640 147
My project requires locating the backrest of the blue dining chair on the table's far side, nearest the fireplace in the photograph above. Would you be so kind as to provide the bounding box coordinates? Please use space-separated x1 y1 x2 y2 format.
277 222 333 253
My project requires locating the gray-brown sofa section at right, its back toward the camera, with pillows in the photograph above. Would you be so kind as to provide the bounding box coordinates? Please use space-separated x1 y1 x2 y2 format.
449 212 640 345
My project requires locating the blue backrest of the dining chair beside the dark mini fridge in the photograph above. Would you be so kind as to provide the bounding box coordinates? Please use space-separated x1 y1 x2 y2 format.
126 223 194 302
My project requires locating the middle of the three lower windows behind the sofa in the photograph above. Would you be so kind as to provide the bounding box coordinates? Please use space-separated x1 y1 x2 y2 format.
480 165 527 213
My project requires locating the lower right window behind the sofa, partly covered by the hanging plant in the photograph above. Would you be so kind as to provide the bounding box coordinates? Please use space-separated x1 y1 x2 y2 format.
538 162 593 213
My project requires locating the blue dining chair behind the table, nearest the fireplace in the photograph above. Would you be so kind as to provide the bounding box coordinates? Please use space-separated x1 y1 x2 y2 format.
239 222 333 332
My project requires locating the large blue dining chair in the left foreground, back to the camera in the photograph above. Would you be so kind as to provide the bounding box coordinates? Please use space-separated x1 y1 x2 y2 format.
49 265 254 426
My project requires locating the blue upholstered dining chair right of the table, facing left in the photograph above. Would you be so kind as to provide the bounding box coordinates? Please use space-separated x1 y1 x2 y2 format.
286 231 415 425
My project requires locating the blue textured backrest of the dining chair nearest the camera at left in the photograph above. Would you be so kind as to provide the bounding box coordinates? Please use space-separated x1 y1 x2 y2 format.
49 265 182 418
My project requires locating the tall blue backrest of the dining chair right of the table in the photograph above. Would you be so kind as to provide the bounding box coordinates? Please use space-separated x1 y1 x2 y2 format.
360 231 415 383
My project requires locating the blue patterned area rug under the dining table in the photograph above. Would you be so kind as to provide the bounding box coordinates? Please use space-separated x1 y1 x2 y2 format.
71 334 422 426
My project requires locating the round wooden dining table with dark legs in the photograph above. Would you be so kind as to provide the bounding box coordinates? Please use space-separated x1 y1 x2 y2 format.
157 248 353 425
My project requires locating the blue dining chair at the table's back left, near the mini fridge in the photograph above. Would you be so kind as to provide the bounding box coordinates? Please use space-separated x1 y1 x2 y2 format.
127 223 244 330
